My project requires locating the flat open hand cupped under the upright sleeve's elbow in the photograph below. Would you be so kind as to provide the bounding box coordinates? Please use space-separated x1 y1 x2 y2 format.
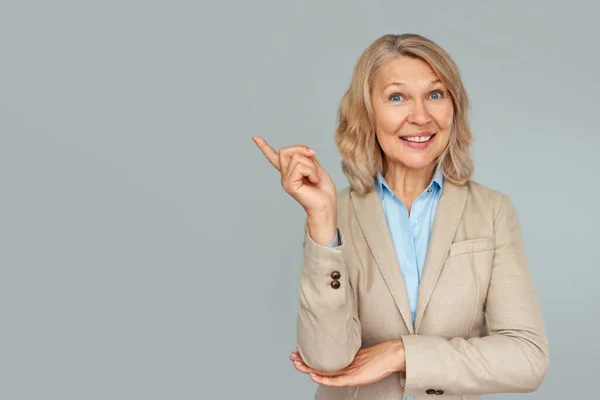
290 340 405 386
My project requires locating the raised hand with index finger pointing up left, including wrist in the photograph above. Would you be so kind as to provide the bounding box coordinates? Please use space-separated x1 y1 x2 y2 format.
252 136 337 245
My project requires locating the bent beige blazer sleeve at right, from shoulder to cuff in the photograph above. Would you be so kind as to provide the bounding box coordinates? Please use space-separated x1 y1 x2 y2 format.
402 196 549 396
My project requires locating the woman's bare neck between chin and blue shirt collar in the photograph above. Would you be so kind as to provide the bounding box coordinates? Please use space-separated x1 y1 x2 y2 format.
384 164 435 204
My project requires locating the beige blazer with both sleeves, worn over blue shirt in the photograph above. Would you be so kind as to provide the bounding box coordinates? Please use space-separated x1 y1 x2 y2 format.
297 181 549 400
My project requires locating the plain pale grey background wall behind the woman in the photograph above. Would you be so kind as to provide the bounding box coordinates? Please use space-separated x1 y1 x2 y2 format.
0 0 600 400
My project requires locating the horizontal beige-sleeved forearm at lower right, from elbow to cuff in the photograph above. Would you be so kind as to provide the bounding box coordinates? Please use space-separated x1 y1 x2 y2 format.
402 331 548 396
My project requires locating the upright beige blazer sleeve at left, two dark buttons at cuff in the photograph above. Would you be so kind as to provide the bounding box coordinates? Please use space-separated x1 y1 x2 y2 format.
297 227 361 372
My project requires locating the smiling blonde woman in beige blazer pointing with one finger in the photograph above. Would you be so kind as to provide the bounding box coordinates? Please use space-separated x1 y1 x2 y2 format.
253 34 548 400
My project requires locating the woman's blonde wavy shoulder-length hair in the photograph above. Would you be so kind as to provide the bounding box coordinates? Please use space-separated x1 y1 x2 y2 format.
335 33 473 195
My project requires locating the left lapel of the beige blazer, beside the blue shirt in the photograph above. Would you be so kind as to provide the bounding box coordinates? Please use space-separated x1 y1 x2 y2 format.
351 189 414 334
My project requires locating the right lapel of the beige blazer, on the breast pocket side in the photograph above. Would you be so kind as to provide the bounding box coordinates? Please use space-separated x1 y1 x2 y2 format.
415 181 468 333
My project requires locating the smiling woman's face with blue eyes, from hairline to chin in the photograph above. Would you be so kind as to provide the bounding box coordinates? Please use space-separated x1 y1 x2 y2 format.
371 57 454 169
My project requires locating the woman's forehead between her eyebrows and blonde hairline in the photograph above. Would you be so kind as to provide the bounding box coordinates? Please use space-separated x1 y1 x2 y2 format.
375 57 439 87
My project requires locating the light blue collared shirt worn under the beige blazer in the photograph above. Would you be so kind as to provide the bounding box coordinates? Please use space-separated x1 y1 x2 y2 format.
330 167 444 400
